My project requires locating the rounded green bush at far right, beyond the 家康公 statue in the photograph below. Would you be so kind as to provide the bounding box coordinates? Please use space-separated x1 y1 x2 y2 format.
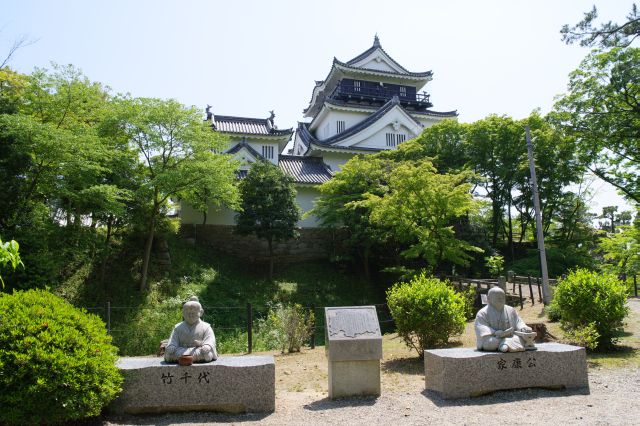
552 269 629 349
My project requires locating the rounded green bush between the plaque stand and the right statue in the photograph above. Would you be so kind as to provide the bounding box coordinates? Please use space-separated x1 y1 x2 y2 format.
387 274 466 358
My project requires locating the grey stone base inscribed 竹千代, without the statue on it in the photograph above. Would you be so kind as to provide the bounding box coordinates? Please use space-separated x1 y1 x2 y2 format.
110 356 276 414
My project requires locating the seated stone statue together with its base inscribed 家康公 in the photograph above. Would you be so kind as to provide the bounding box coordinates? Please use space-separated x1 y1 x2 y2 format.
424 287 589 399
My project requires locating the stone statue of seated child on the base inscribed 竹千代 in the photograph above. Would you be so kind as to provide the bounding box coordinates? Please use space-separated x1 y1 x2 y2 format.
164 296 218 362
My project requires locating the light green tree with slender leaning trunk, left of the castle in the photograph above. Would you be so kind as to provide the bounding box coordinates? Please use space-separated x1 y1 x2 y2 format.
109 98 238 290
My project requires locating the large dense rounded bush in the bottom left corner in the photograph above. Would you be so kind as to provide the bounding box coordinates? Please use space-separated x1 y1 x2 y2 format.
0 290 122 424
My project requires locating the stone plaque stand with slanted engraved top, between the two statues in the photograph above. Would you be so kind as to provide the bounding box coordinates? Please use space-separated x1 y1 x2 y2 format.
324 306 382 399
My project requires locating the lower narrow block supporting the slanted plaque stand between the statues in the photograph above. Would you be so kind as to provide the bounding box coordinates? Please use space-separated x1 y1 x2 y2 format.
329 359 380 399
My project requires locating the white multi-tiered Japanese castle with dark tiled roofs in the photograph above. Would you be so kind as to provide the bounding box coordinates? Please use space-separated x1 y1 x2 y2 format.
181 35 458 228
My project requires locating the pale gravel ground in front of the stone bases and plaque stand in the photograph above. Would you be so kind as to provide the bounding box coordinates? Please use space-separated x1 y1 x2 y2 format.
102 369 640 426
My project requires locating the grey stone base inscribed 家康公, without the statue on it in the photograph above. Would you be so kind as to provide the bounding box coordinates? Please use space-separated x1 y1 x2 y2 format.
424 343 589 399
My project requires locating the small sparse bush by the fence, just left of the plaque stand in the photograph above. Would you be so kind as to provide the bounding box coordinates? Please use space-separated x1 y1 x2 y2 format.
258 303 315 353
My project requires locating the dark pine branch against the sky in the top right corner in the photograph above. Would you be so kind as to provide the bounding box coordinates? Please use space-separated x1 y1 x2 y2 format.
560 3 640 48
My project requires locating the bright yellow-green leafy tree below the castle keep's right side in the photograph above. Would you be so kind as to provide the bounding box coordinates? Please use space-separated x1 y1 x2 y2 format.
362 160 482 268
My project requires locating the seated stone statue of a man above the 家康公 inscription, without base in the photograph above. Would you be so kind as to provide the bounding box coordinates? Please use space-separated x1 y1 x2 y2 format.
475 287 536 352
